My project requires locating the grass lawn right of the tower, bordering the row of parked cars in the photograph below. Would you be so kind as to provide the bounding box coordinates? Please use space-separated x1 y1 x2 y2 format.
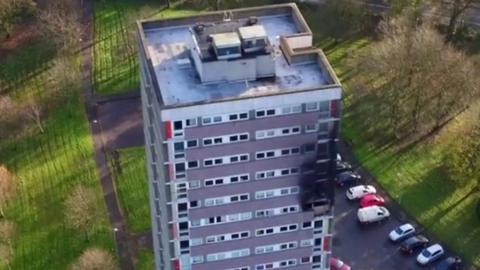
307 17 480 267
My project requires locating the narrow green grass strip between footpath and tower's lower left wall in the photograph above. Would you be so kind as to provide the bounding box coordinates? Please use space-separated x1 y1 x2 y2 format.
109 147 151 233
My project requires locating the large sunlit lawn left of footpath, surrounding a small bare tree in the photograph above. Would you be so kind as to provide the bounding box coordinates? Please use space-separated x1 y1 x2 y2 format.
0 88 114 270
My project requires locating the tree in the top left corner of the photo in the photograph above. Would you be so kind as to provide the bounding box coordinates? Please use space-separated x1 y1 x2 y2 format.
0 0 36 38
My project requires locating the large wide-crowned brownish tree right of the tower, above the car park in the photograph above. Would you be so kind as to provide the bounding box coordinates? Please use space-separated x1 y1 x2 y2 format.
358 15 480 138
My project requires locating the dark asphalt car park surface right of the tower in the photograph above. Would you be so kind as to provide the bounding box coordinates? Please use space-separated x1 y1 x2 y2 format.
332 144 466 270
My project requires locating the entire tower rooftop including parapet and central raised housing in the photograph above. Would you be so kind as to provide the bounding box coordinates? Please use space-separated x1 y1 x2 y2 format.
139 5 338 106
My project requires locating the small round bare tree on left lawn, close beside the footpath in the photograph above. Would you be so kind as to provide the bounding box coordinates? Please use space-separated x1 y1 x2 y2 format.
65 186 103 239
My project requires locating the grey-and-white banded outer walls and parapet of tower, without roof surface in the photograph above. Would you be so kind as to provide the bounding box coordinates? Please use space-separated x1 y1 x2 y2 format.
138 4 341 270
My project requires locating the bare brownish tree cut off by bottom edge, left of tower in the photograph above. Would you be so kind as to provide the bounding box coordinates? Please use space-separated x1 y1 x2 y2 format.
71 248 118 270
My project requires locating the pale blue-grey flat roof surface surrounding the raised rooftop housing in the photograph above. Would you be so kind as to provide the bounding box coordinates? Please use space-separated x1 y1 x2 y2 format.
139 5 340 106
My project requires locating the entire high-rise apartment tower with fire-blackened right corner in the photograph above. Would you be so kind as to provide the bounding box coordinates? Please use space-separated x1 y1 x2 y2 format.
138 4 342 270
